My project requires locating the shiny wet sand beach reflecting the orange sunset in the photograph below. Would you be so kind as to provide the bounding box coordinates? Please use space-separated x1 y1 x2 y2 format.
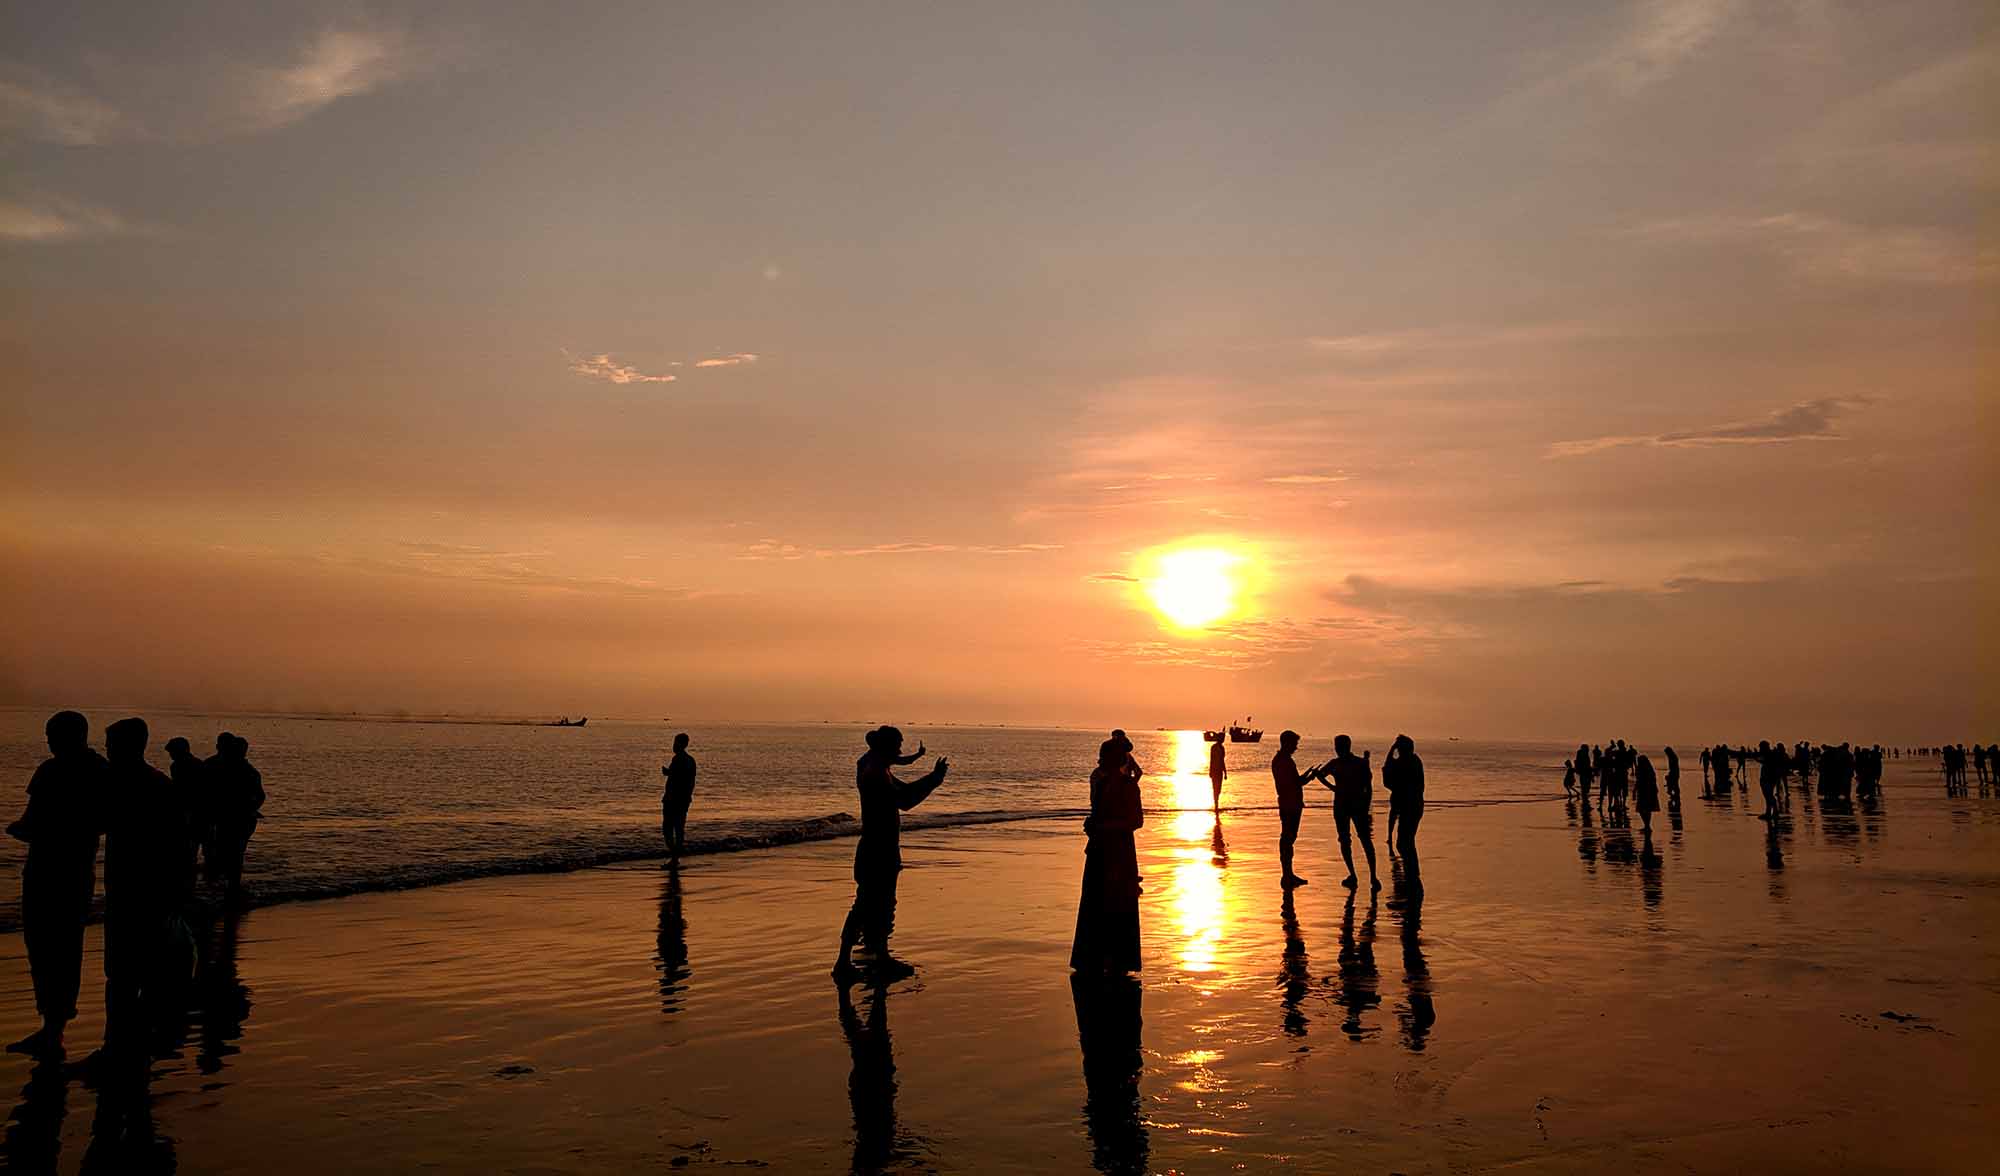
0 786 2000 1172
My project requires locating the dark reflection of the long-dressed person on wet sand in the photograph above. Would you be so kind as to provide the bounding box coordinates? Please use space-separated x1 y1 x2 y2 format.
1070 968 1152 1176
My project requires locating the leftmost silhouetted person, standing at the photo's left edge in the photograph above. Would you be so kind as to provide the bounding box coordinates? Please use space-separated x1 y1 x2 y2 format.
6 710 106 1056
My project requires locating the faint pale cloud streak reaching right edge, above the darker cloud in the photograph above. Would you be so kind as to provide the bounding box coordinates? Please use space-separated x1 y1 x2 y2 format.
1626 212 2000 284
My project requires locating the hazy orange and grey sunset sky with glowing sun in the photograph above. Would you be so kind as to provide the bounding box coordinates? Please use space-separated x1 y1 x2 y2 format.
0 0 2000 742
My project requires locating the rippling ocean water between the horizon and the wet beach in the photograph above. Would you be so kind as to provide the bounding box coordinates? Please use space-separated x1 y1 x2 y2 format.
0 708 1936 930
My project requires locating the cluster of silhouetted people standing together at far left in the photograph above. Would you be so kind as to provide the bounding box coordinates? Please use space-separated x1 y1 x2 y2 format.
6 710 264 1066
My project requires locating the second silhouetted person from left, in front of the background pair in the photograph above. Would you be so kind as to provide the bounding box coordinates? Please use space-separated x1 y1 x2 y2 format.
98 718 194 1064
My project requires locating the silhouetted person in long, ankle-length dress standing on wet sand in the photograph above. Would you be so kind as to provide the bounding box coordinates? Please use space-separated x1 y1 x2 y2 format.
1070 732 1146 972
